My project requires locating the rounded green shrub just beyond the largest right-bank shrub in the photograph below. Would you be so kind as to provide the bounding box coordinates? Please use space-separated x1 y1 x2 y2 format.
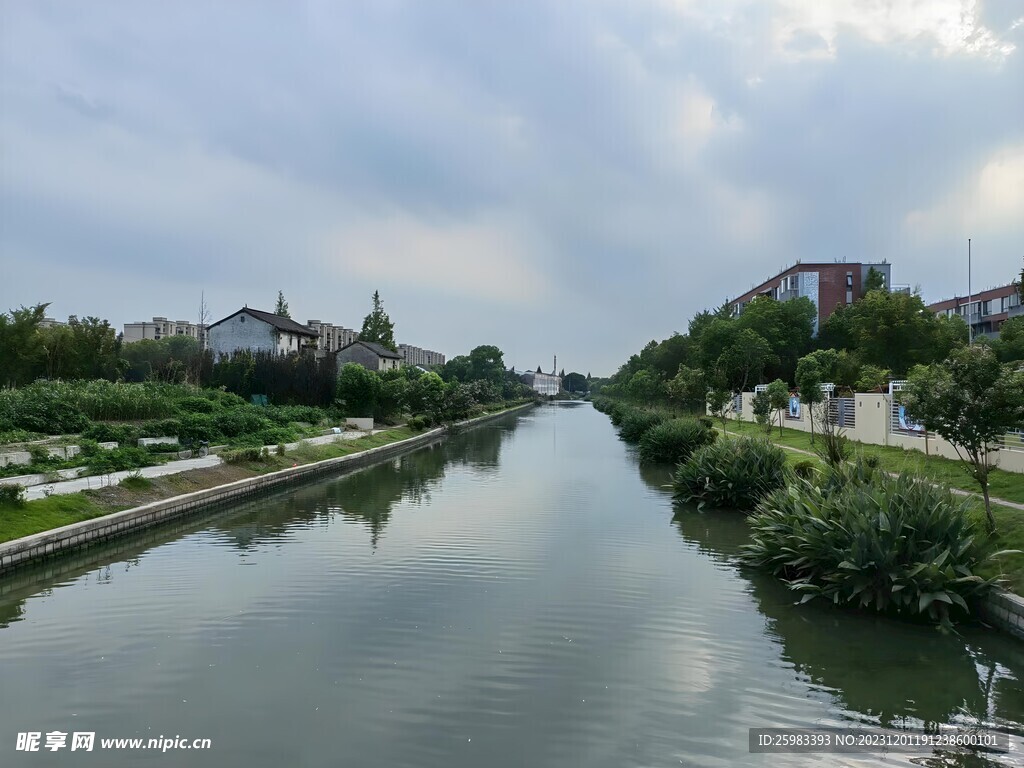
674 437 786 510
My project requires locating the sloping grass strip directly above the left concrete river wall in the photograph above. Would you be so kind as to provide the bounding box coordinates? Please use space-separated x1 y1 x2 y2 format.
0 427 416 542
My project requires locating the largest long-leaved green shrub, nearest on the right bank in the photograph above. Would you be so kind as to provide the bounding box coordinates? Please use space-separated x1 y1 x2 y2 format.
743 471 1002 627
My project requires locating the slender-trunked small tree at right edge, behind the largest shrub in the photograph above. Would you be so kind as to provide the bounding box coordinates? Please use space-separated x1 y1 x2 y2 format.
899 344 1024 531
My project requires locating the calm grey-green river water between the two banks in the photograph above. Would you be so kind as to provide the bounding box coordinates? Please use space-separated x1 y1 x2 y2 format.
0 404 1024 768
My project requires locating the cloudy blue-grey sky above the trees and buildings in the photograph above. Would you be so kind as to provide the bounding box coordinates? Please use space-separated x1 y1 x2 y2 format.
0 0 1024 375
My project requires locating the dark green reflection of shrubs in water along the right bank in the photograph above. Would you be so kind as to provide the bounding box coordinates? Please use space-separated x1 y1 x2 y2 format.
641 467 1024 753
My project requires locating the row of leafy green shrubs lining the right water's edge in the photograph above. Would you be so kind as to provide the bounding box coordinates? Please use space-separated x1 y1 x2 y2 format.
594 397 1024 638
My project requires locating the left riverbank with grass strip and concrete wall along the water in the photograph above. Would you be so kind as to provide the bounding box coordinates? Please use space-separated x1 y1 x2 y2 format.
0 402 536 573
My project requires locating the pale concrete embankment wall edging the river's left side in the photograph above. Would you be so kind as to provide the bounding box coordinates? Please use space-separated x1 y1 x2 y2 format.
0 402 535 574
